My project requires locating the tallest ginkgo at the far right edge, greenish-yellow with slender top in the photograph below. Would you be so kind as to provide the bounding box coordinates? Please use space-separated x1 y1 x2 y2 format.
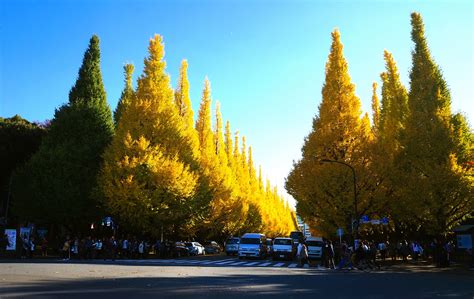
399 13 474 236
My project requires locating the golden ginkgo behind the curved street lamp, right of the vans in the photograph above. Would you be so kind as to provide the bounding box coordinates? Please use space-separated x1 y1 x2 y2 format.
286 30 371 234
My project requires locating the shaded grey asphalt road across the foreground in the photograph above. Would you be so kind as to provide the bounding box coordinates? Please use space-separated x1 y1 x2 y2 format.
0 256 474 299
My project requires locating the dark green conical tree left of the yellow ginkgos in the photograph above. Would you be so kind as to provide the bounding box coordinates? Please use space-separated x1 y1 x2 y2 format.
13 36 113 231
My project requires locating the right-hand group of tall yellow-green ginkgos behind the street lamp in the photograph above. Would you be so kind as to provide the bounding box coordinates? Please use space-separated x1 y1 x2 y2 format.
286 13 474 241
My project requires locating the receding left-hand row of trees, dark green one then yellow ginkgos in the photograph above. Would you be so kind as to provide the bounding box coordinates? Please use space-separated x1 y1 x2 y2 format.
12 35 296 238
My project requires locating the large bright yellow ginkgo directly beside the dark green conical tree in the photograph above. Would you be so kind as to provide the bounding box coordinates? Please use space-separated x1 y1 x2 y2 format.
100 35 198 236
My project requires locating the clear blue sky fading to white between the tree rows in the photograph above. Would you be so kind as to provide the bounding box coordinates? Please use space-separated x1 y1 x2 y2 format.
0 0 474 206
